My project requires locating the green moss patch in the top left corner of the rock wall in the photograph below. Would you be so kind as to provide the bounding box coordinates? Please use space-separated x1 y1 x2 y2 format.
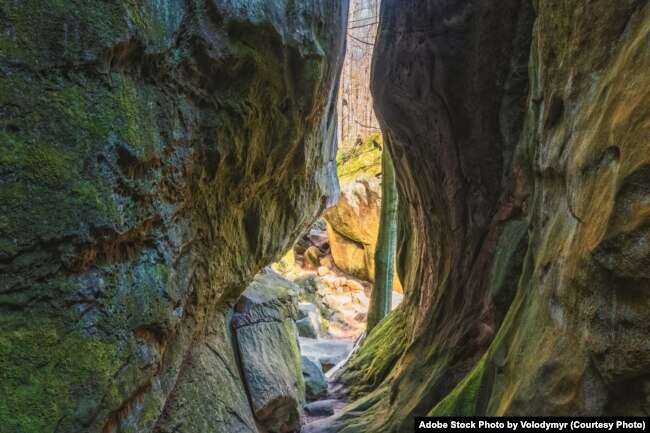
0 0 184 68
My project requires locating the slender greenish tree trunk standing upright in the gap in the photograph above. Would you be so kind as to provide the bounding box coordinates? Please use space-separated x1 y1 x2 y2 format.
367 143 398 333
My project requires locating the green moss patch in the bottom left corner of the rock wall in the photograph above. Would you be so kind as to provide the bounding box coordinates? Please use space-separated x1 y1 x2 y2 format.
0 313 121 433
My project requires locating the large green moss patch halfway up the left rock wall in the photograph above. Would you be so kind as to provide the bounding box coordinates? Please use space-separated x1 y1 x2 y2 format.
0 74 163 254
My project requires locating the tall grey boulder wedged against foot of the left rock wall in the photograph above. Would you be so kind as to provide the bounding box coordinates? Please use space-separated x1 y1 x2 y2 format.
232 268 305 432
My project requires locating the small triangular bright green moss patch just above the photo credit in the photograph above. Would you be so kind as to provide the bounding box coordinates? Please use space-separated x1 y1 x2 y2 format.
427 355 488 416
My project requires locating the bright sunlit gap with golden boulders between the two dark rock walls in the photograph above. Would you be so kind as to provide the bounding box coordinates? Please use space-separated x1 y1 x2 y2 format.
272 0 402 346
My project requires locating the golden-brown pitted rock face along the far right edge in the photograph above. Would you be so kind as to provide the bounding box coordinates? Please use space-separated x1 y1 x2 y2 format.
477 1 650 416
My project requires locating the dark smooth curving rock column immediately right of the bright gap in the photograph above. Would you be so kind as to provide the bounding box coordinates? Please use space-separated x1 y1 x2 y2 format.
338 0 534 432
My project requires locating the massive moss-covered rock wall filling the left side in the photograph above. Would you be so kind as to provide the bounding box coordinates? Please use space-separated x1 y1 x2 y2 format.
0 0 347 433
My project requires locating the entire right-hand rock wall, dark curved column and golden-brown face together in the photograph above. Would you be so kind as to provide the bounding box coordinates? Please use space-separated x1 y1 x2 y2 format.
332 0 650 426
